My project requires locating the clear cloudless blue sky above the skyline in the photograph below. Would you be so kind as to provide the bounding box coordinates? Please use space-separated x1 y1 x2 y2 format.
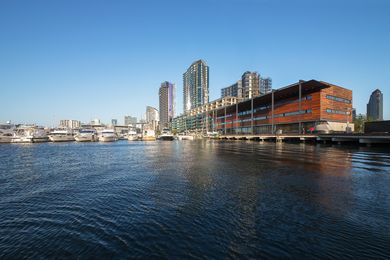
0 0 390 126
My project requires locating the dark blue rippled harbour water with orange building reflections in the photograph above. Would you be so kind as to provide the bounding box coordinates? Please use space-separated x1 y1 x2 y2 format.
0 141 390 259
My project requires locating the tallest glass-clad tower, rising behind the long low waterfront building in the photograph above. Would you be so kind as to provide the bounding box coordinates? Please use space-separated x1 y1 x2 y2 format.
183 60 209 113
